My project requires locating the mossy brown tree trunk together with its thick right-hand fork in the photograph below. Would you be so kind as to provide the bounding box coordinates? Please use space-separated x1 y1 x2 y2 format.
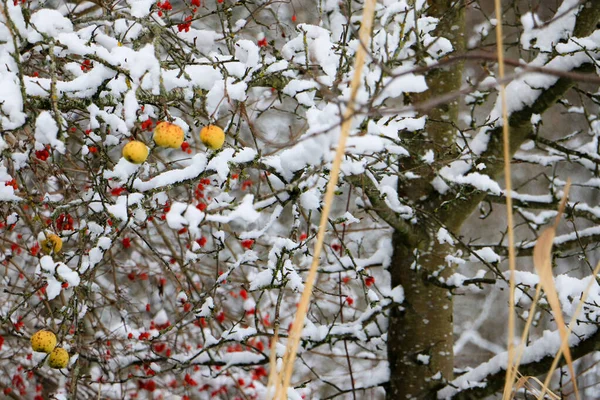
386 0 600 400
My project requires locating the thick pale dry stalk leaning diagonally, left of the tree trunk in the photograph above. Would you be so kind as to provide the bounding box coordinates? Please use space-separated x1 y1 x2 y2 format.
269 0 376 400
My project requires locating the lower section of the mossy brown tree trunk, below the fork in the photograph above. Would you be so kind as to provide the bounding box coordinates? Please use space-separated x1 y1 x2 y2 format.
387 235 453 399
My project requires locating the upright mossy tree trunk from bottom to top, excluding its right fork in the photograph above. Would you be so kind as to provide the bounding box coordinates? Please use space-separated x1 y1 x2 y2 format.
387 0 465 400
